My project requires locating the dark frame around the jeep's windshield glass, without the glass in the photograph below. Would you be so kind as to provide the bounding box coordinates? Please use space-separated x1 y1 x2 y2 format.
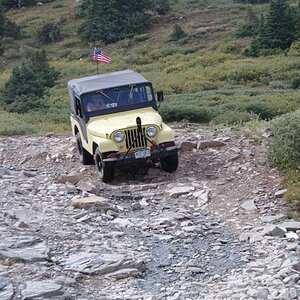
80 82 158 118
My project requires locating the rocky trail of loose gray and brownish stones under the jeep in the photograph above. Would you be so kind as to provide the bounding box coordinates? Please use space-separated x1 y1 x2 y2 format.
0 125 300 300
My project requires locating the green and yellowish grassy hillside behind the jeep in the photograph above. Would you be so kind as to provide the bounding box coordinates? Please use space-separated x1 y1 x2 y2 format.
0 0 300 135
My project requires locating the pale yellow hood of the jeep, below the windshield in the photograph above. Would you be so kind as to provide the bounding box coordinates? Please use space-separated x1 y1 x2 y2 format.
87 107 162 137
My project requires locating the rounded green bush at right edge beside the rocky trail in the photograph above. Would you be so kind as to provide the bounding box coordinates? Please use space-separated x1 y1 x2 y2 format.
268 110 300 170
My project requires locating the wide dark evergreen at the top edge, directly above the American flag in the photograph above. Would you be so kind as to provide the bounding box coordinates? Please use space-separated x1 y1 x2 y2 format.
79 0 151 43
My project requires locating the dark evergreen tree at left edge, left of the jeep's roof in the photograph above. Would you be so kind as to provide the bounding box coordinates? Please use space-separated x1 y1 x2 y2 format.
0 50 59 113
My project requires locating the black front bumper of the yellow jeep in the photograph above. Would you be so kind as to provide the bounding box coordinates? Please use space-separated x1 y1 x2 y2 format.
103 146 178 166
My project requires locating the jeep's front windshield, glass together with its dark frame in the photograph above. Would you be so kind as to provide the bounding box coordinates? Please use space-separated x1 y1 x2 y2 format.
82 84 157 116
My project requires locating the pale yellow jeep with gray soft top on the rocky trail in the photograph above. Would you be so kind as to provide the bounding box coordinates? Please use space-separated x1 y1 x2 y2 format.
68 70 178 182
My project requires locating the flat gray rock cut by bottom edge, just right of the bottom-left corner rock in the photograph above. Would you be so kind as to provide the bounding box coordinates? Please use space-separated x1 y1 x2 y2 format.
22 281 64 300
